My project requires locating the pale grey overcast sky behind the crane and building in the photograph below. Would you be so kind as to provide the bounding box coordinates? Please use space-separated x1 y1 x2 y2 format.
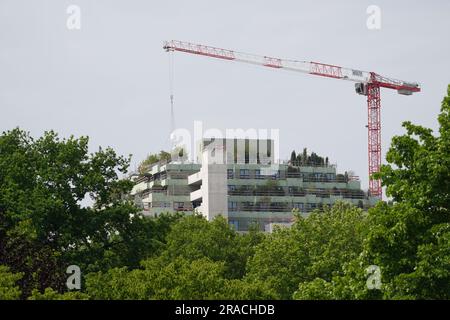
0 0 450 187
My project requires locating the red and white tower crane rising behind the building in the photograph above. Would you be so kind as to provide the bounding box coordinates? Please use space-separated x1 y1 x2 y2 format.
164 40 420 198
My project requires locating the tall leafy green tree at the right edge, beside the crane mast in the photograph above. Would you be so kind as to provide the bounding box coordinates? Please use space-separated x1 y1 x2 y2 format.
316 86 450 299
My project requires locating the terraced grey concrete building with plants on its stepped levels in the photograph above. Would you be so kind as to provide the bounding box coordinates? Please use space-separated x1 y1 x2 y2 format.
131 139 379 231
